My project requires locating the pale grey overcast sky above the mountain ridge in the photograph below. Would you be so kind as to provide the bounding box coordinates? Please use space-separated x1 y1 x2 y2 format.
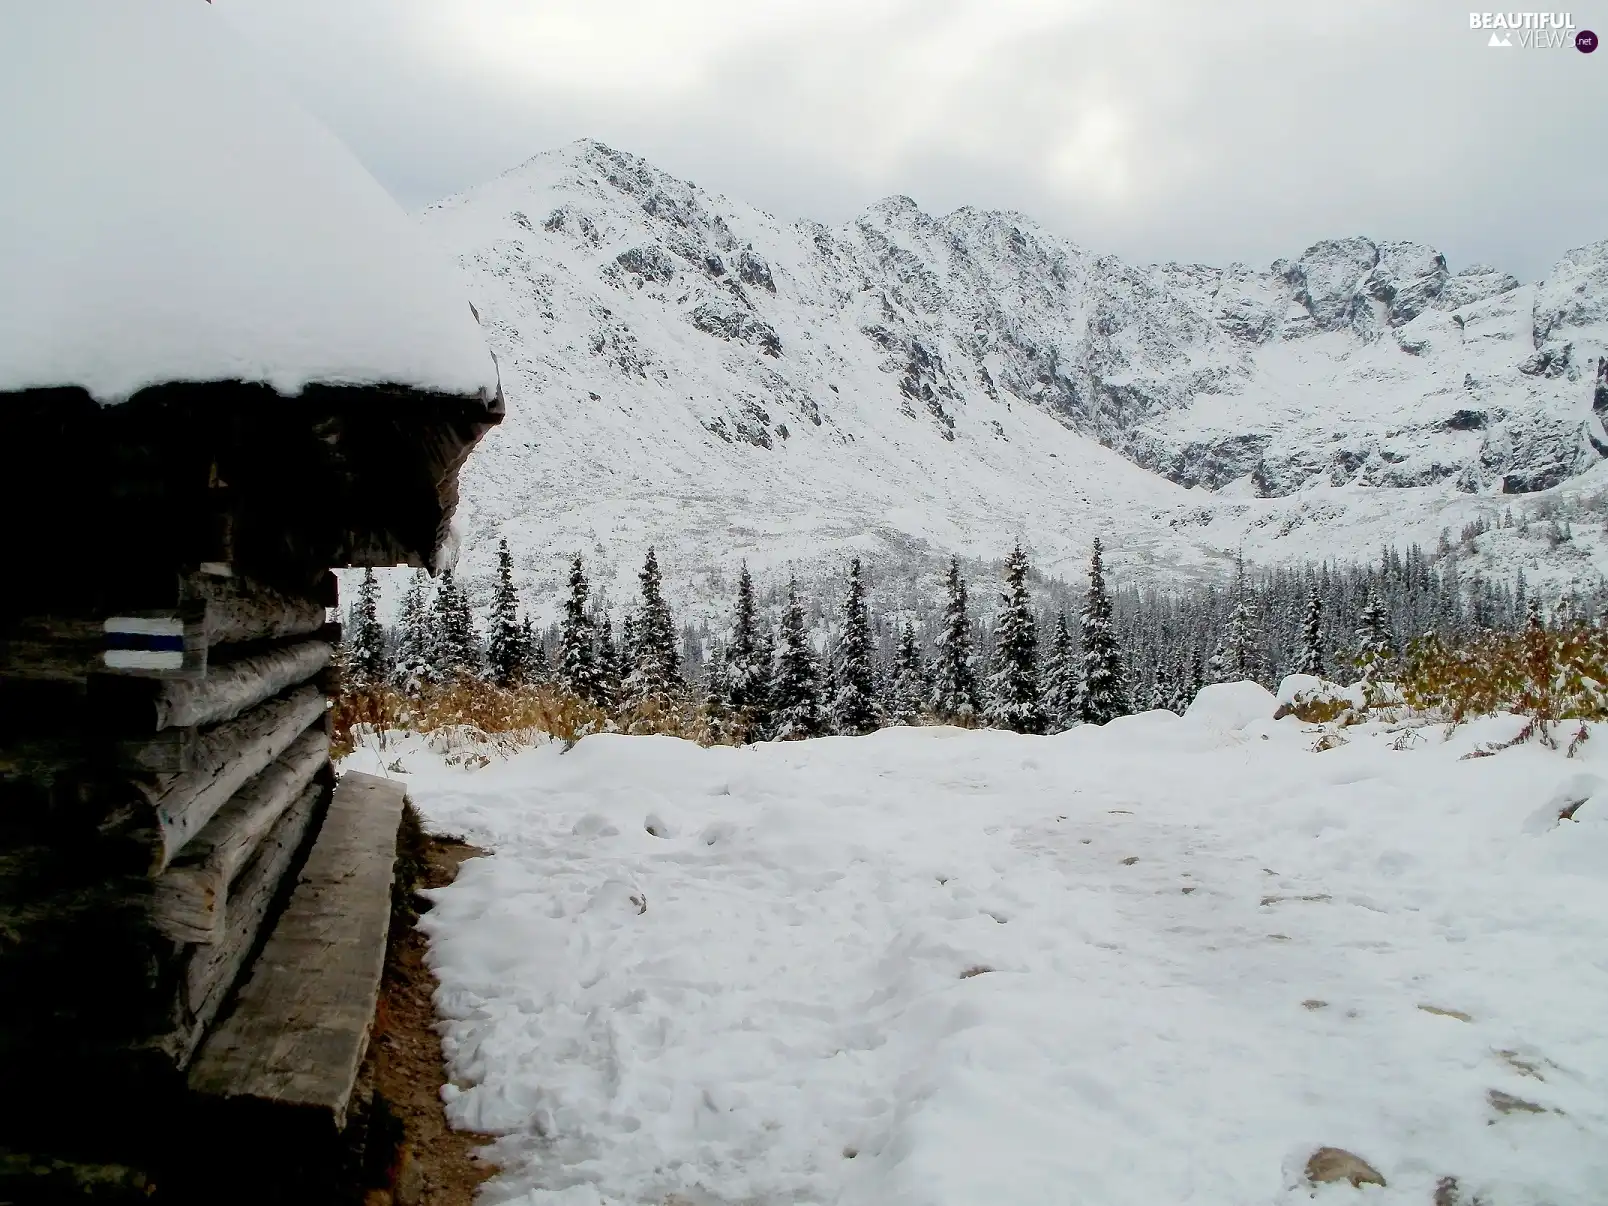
217 0 1608 280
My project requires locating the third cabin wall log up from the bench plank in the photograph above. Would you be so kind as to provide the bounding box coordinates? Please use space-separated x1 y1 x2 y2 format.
136 685 326 876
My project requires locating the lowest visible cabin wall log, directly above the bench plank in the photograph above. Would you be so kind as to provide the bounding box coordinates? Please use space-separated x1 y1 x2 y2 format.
172 781 328 1068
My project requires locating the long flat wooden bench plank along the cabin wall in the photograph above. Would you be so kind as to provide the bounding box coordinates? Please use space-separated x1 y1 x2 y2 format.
190 773 407 1130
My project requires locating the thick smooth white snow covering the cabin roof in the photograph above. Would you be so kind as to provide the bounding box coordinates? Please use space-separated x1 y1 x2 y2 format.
0 0 497 402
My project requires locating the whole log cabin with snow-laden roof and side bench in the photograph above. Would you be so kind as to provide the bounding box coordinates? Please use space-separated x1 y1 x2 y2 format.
0 0 503 1201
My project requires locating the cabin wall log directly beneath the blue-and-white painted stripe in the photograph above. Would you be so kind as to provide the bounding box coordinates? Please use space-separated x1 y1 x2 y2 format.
88 640 334 733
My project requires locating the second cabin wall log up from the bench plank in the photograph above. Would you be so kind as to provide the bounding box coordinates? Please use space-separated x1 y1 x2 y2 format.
151 725 330 944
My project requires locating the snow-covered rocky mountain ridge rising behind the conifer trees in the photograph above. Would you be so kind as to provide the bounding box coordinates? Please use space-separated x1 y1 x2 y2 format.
421 142 1608 614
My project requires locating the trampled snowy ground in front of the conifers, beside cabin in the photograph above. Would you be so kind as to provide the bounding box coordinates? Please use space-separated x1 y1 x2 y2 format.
347 685 1608 1206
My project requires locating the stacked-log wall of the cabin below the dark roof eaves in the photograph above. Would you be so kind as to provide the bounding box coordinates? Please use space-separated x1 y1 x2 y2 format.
0 574 336 1158
